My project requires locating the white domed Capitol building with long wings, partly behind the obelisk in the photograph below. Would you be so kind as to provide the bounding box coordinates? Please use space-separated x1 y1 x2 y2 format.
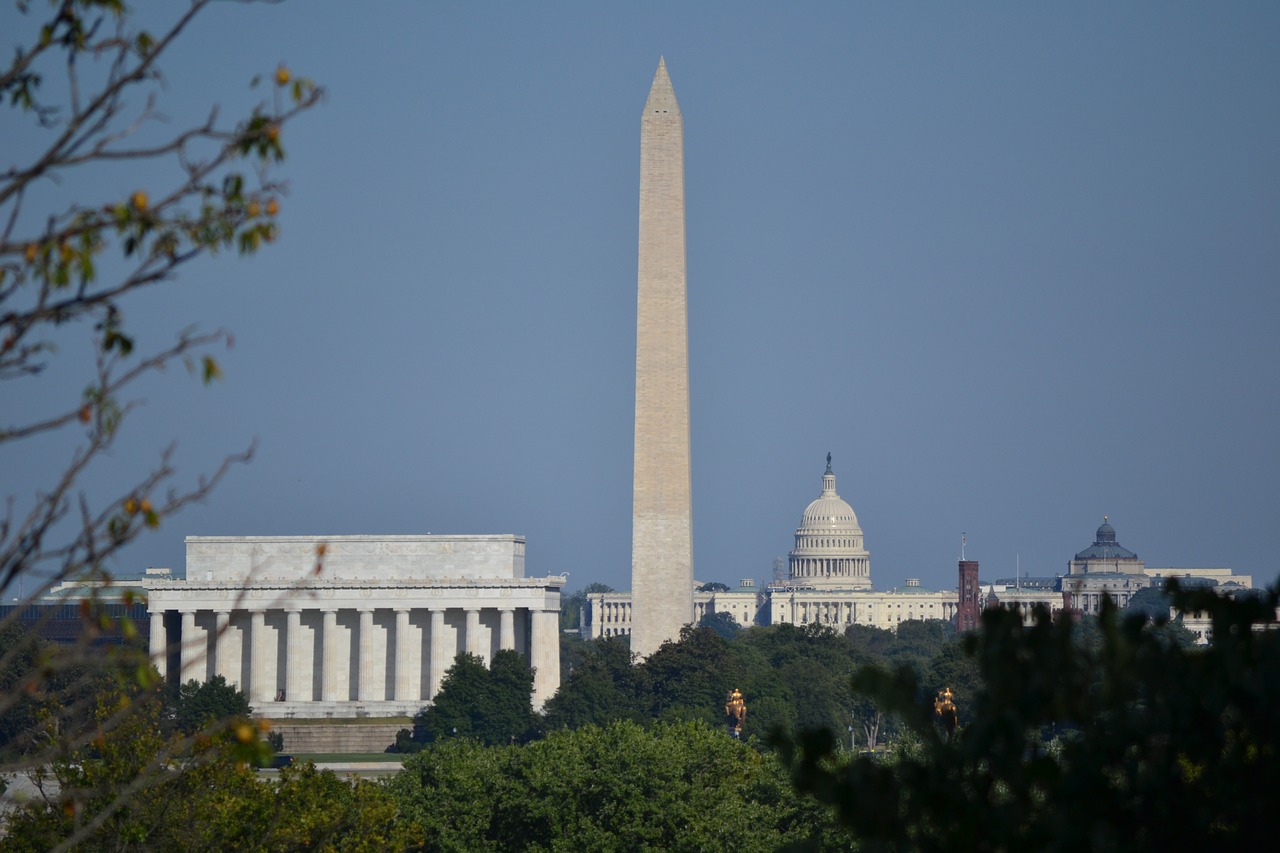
581 453 959 638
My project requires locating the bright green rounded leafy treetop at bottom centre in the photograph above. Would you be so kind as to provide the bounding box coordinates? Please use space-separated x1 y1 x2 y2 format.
389 722 850 850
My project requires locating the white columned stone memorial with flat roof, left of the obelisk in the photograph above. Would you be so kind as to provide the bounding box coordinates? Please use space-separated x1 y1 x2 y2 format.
146 535 564 719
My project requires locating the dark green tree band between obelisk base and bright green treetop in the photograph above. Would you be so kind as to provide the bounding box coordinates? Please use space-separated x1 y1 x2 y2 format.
398 620 977 752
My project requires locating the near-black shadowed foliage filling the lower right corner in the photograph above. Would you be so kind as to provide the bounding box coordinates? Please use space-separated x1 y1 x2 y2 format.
783 584 1280 850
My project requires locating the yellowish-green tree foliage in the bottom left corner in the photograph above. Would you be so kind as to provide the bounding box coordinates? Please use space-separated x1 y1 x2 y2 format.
0 688 422 850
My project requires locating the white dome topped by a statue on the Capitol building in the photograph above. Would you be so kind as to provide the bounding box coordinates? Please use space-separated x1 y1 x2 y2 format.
788 453 872 589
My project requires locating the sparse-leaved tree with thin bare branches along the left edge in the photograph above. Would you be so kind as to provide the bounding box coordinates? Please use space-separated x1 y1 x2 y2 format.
0 0 321 844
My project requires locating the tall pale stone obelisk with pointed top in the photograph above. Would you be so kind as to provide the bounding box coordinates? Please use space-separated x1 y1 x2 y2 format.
631 60 694 658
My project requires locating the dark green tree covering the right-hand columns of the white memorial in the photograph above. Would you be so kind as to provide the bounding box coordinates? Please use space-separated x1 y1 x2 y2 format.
397 649 539 752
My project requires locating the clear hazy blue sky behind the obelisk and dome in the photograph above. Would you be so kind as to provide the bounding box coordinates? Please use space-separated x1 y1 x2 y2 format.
0 0 1280 588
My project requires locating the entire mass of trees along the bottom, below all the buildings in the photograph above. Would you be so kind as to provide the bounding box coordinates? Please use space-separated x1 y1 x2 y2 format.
0 588 1280 850
